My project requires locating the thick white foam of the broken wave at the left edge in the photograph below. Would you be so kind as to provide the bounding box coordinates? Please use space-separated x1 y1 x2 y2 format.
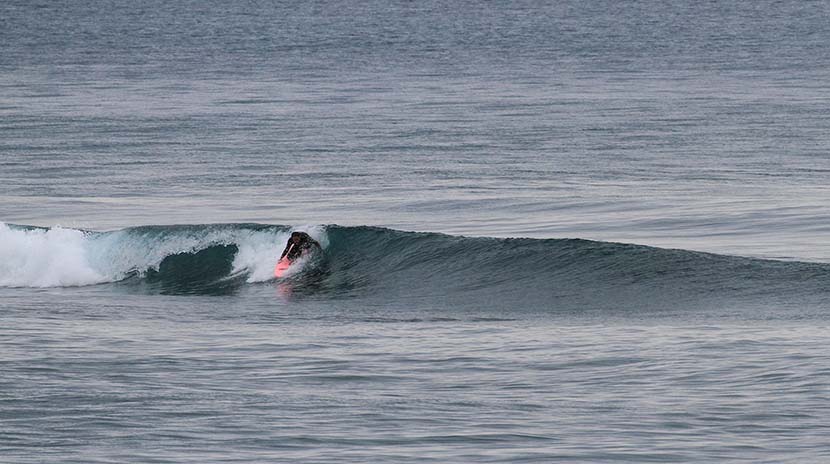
0 223 109 287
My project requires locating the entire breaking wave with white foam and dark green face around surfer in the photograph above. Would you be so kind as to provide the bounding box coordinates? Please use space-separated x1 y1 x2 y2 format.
0 224 830 310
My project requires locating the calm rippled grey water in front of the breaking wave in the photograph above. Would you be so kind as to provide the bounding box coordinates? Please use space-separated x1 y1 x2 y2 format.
0 294 830 462
